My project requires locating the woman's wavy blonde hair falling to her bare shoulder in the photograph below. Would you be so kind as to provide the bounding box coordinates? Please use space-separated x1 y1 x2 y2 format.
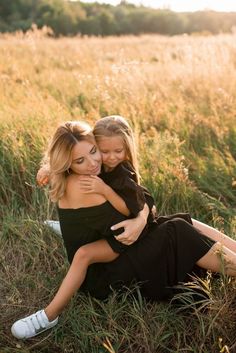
46 121 95 202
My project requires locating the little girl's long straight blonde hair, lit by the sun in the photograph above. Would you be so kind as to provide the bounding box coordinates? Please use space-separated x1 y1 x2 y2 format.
93 115 139 181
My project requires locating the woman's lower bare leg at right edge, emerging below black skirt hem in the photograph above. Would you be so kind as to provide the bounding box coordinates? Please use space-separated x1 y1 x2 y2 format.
197 242 236 276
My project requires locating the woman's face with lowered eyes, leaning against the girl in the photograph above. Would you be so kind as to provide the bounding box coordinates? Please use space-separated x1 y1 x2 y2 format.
70 141 102 175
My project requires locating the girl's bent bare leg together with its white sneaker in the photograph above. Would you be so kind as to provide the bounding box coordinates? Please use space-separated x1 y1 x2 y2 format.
11 240 118 339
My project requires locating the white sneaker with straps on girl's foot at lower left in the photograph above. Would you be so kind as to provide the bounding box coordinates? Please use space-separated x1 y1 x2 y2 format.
11 310 58 339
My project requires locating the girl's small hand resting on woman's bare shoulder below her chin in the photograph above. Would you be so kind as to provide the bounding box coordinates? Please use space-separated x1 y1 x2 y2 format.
78 175 107 195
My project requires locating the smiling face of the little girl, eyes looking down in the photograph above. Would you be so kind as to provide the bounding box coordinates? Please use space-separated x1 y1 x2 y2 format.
98 135 126 171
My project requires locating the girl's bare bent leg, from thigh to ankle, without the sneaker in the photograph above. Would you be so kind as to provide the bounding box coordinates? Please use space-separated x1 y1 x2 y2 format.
45 239 118 321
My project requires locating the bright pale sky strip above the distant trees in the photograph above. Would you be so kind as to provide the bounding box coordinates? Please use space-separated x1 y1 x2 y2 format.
79 0 236 12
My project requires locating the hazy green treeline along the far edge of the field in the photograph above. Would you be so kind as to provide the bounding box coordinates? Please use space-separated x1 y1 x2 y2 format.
0 0 236 36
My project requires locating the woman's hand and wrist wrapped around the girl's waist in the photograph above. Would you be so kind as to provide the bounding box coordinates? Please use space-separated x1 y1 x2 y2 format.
111 204 149 245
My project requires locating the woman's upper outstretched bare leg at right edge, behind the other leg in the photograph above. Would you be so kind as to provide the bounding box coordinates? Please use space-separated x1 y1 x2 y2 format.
192 218 236 253
